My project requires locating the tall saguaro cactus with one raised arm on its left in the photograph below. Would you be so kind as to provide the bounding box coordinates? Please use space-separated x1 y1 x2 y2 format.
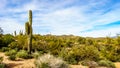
25 10 32 54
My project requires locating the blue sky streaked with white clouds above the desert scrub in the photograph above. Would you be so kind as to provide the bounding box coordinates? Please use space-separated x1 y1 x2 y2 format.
0 0 120 37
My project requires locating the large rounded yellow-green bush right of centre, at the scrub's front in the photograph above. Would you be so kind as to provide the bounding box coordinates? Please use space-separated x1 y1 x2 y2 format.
76 46 99 61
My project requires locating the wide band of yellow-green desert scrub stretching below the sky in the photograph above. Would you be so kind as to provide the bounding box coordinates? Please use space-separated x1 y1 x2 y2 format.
0 31 120 67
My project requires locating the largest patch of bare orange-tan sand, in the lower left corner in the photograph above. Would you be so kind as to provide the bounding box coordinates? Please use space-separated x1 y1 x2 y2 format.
0 52 35 68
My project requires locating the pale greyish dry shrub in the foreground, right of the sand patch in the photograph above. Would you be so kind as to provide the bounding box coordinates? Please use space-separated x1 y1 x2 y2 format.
35 54 69 68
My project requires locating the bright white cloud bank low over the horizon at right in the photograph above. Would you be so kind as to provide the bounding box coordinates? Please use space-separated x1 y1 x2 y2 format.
80 27 120 37
